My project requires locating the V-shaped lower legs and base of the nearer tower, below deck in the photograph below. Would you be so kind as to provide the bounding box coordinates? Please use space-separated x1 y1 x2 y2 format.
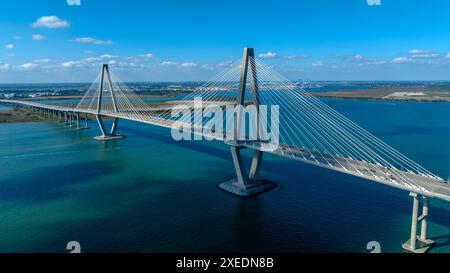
219 145 276 197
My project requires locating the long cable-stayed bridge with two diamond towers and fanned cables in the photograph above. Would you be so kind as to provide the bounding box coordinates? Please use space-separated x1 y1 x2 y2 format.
0 48 450 252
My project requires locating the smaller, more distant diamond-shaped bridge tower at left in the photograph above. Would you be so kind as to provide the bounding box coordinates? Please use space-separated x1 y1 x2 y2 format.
94 64 125 141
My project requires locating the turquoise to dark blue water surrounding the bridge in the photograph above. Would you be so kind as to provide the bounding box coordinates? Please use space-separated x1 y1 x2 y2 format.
0 99 450 252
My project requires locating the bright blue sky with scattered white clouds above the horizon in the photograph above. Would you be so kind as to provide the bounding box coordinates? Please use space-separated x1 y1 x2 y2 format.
0 0 450 83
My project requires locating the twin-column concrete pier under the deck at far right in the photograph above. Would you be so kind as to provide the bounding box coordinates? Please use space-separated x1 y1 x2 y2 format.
403 193 434 253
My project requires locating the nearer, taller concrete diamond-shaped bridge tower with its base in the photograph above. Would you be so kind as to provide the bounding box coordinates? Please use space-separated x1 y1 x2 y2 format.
219 48 276 197
